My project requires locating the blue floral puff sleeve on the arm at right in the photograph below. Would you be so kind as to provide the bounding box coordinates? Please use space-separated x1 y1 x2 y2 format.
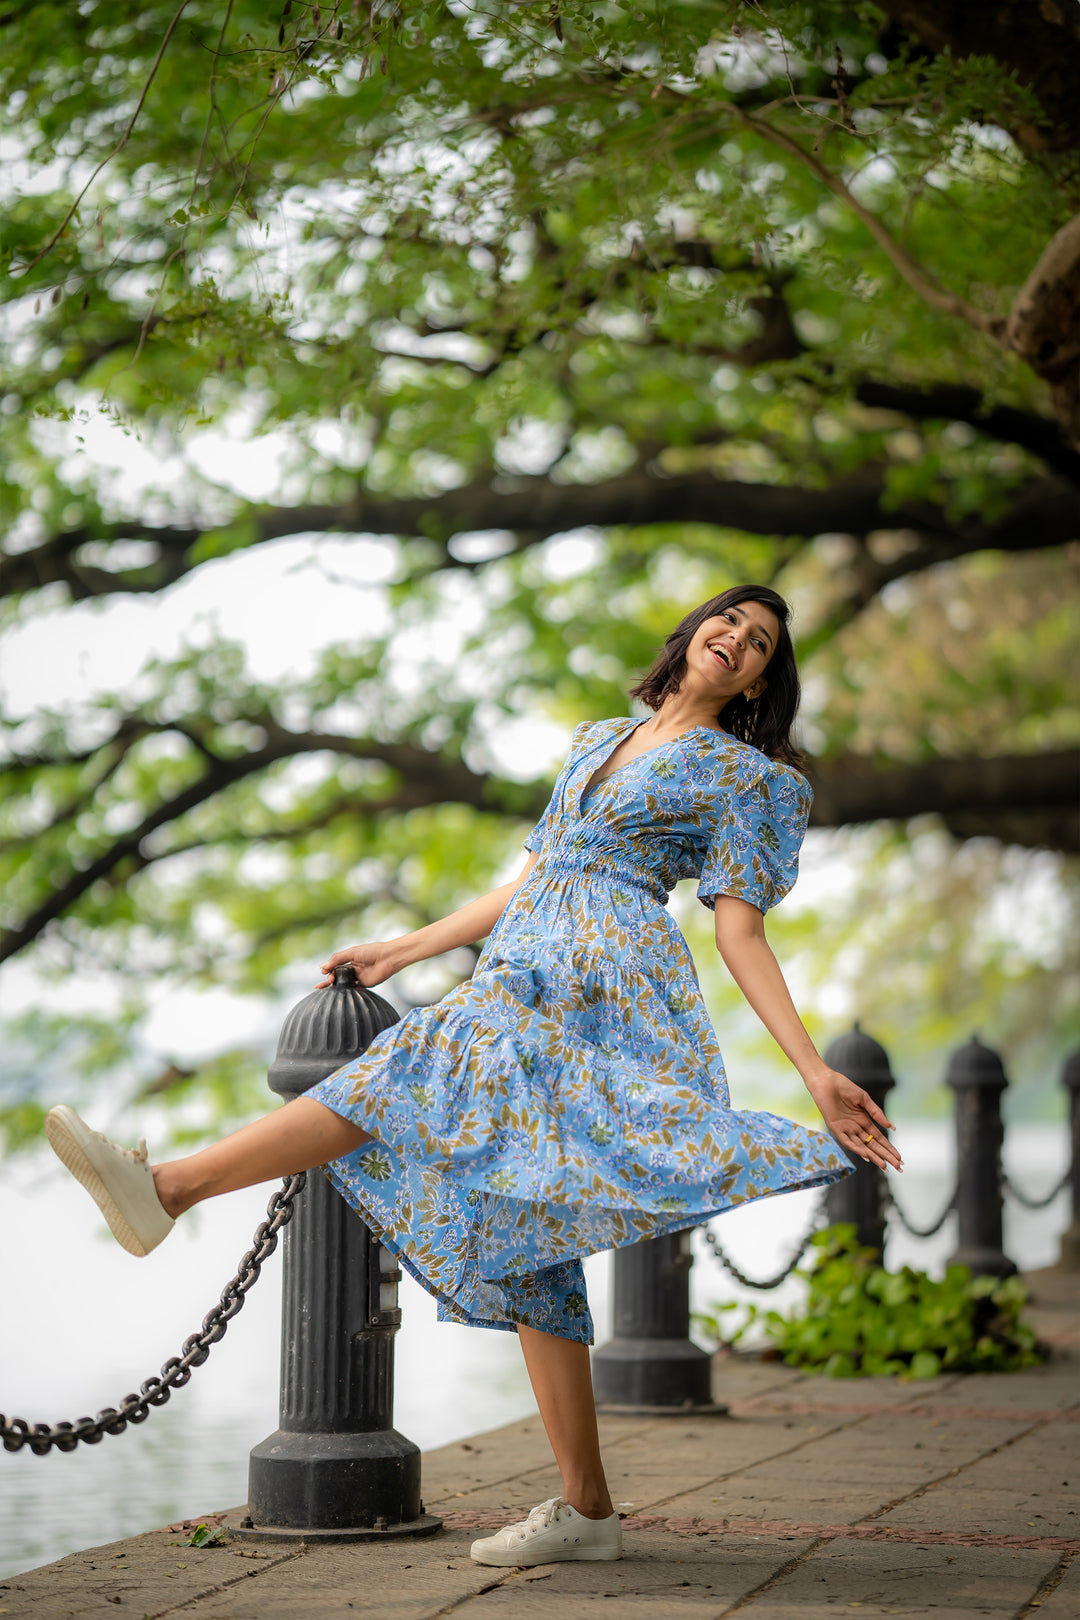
698 766 813 912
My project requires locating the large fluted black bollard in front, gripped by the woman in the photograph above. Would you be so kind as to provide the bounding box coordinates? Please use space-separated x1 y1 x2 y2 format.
230 966 442 1541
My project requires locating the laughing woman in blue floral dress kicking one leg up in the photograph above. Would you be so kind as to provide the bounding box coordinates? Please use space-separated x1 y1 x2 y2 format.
47 586 900 1565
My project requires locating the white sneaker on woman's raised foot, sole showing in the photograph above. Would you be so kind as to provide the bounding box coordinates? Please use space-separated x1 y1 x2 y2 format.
45 1103 175 1256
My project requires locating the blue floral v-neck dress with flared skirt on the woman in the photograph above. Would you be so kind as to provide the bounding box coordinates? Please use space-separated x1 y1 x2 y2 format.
308 719 852 1343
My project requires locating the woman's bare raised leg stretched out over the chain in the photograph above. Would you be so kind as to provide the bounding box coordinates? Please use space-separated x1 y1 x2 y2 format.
154 1097 371 1217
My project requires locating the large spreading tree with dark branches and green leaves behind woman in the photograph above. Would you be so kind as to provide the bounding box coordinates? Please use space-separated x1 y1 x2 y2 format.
0 0 1080 1140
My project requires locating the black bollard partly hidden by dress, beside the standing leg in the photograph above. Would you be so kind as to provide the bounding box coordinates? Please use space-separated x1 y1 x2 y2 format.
593 1231 727 1416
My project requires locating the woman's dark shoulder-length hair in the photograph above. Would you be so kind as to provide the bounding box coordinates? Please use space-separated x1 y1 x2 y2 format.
630 585 803 770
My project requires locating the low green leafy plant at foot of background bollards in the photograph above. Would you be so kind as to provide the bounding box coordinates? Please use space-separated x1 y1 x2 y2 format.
698 1226 1046 1379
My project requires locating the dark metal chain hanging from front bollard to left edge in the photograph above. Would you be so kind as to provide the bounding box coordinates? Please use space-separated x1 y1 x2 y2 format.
0 1173 308 1456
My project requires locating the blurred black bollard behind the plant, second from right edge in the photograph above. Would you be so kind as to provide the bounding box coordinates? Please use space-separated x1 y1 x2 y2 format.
946 1035 1015 1277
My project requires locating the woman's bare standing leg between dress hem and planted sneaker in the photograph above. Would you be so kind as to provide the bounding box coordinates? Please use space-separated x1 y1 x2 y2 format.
518 1327 615 1518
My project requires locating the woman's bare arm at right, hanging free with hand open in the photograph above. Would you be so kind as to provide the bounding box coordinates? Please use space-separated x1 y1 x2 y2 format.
714 894 904 1170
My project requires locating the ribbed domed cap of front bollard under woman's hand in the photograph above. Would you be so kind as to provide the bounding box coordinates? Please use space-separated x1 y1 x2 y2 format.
269 962 398 1097
